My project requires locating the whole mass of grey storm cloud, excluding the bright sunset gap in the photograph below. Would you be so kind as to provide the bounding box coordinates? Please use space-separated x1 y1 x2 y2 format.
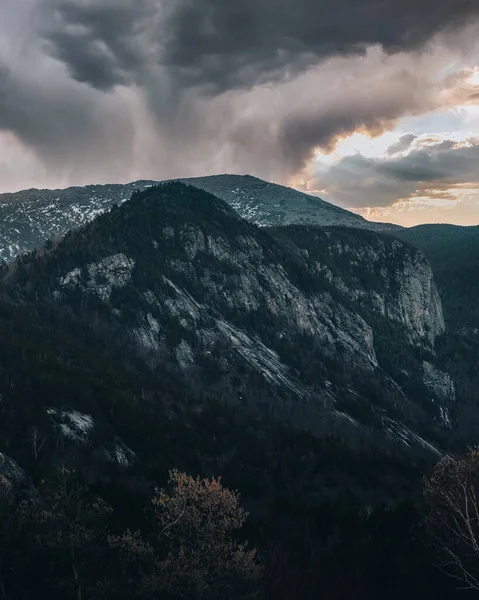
0 0 479 192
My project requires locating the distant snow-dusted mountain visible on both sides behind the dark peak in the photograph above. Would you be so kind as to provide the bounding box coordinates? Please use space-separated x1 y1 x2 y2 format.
0 175 397 260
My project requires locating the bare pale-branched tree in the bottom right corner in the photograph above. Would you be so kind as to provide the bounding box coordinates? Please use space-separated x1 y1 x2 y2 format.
424 449 479 592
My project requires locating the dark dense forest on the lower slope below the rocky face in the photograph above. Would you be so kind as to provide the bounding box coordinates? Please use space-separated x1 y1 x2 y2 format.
0 301 454 599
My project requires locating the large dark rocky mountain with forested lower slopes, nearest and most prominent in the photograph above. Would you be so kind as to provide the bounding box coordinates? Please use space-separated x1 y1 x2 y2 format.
0 183 468 600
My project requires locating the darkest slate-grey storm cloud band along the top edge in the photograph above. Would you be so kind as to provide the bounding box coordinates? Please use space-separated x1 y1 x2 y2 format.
44 0 479 92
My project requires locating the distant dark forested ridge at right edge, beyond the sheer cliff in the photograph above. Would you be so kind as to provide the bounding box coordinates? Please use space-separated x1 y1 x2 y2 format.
394 225 479 335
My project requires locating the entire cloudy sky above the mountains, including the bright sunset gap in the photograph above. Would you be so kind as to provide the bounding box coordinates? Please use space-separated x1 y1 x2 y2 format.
0 0 479 225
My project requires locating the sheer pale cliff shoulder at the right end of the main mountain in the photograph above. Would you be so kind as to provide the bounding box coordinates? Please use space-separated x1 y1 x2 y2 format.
274 227 445 347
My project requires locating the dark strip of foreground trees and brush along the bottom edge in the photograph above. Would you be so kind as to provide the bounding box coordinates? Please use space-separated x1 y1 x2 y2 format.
0 452 479 600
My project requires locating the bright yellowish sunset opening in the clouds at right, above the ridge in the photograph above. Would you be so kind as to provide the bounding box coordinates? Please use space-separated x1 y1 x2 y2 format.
293 67 479 226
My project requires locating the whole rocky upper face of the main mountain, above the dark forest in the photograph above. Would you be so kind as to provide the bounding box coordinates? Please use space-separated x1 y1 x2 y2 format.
7 184 449 451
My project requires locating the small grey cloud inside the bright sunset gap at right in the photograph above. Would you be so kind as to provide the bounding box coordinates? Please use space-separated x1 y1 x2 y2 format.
316 139 479 208
